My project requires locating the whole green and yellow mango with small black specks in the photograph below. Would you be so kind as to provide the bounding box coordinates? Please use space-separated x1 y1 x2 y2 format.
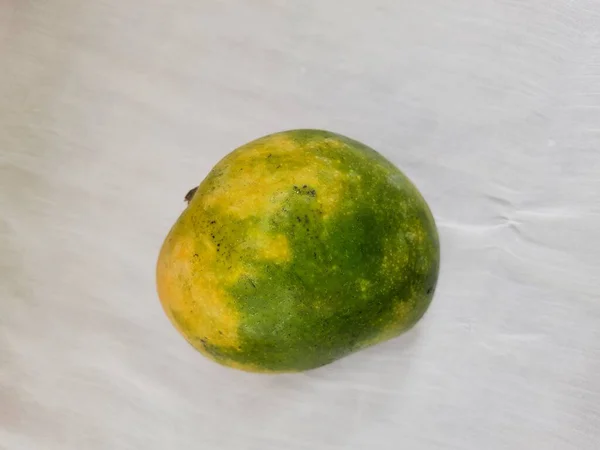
159 130 440 372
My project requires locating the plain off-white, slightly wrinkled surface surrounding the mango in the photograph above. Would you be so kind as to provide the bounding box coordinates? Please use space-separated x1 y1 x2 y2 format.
0 0 600 450
